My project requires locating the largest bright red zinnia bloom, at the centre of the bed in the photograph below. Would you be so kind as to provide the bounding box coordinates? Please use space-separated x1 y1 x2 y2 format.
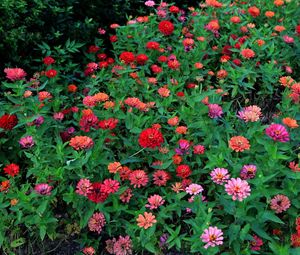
139 128 164 149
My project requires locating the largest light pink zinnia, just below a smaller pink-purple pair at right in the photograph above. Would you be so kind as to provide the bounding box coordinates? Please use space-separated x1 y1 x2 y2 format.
225 178 251 201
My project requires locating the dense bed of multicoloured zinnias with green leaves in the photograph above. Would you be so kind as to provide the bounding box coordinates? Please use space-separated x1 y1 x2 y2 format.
0 0 300 255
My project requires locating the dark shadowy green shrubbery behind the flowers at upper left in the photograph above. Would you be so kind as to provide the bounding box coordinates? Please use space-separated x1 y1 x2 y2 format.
0 0 198 73
